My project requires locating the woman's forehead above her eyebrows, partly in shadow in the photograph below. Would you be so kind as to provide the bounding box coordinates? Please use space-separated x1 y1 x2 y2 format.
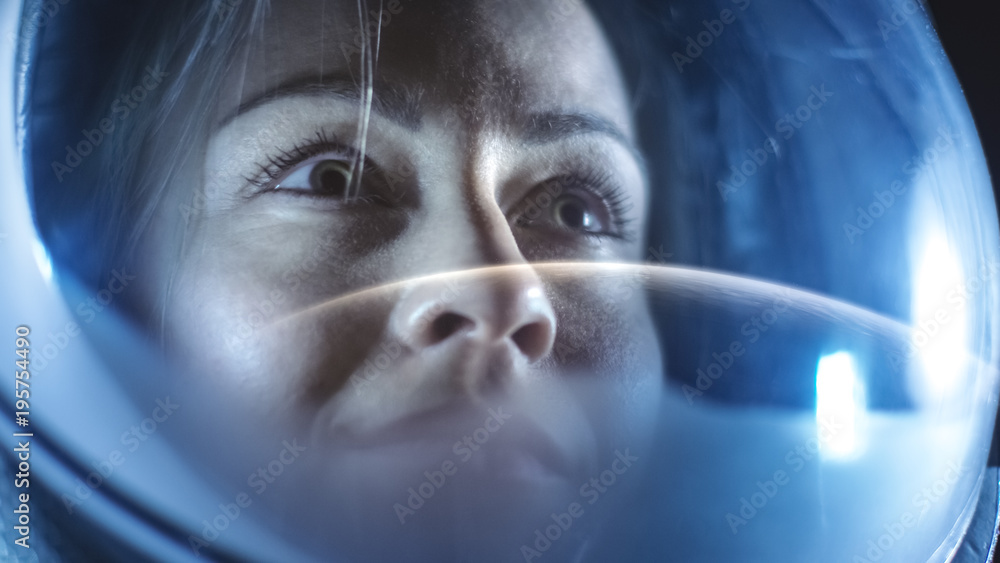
220 0 631 136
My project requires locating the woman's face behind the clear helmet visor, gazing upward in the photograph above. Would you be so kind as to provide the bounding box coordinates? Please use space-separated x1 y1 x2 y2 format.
146 0 662 512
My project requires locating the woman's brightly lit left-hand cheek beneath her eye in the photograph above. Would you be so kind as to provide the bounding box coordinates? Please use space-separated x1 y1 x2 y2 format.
158 218 400 414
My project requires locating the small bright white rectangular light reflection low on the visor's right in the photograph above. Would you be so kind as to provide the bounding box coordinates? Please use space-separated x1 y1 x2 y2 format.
816 351 866 459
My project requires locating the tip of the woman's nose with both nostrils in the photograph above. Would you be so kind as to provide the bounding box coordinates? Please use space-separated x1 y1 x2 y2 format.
391 265 556 363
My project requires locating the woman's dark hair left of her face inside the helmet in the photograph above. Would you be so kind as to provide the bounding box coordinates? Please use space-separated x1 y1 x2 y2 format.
27 0 268 322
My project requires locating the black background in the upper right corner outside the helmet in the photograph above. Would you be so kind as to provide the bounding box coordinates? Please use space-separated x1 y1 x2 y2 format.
927 0 1000 207
